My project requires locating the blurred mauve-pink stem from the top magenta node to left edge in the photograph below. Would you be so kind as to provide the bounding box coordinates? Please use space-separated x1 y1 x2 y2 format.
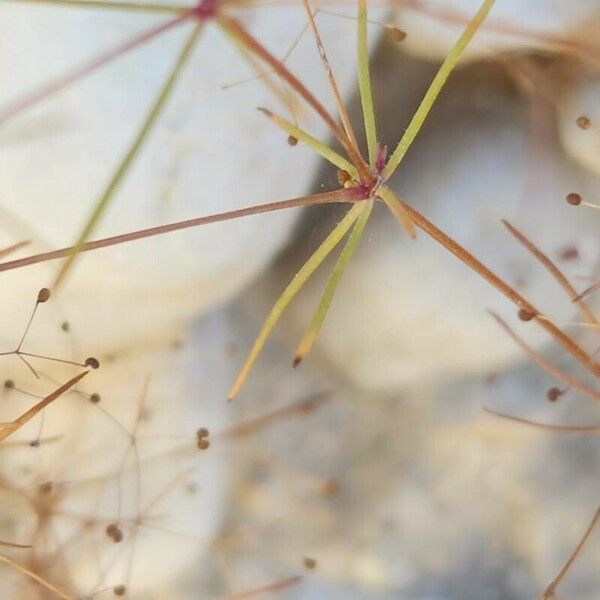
0 10 194 125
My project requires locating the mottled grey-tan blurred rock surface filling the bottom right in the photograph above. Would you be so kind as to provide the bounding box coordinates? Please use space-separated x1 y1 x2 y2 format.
192 292 600 600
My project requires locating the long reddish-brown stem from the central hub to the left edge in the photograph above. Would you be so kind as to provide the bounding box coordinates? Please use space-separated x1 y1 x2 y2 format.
0 189 361 273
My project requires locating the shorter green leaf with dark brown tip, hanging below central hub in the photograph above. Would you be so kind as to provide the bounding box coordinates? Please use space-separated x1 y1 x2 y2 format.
293 200 373 367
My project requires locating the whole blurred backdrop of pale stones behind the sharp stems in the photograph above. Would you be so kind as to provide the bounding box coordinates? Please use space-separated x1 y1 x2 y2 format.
0 0 600 600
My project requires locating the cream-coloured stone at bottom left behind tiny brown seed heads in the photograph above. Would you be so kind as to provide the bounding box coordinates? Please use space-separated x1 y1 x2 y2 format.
0 315 234 600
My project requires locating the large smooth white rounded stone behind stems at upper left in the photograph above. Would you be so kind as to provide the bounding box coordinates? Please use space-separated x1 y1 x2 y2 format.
0 2 376 352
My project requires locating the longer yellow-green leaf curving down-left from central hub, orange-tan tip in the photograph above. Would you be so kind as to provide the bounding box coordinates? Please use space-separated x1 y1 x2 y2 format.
228 204 363 400
